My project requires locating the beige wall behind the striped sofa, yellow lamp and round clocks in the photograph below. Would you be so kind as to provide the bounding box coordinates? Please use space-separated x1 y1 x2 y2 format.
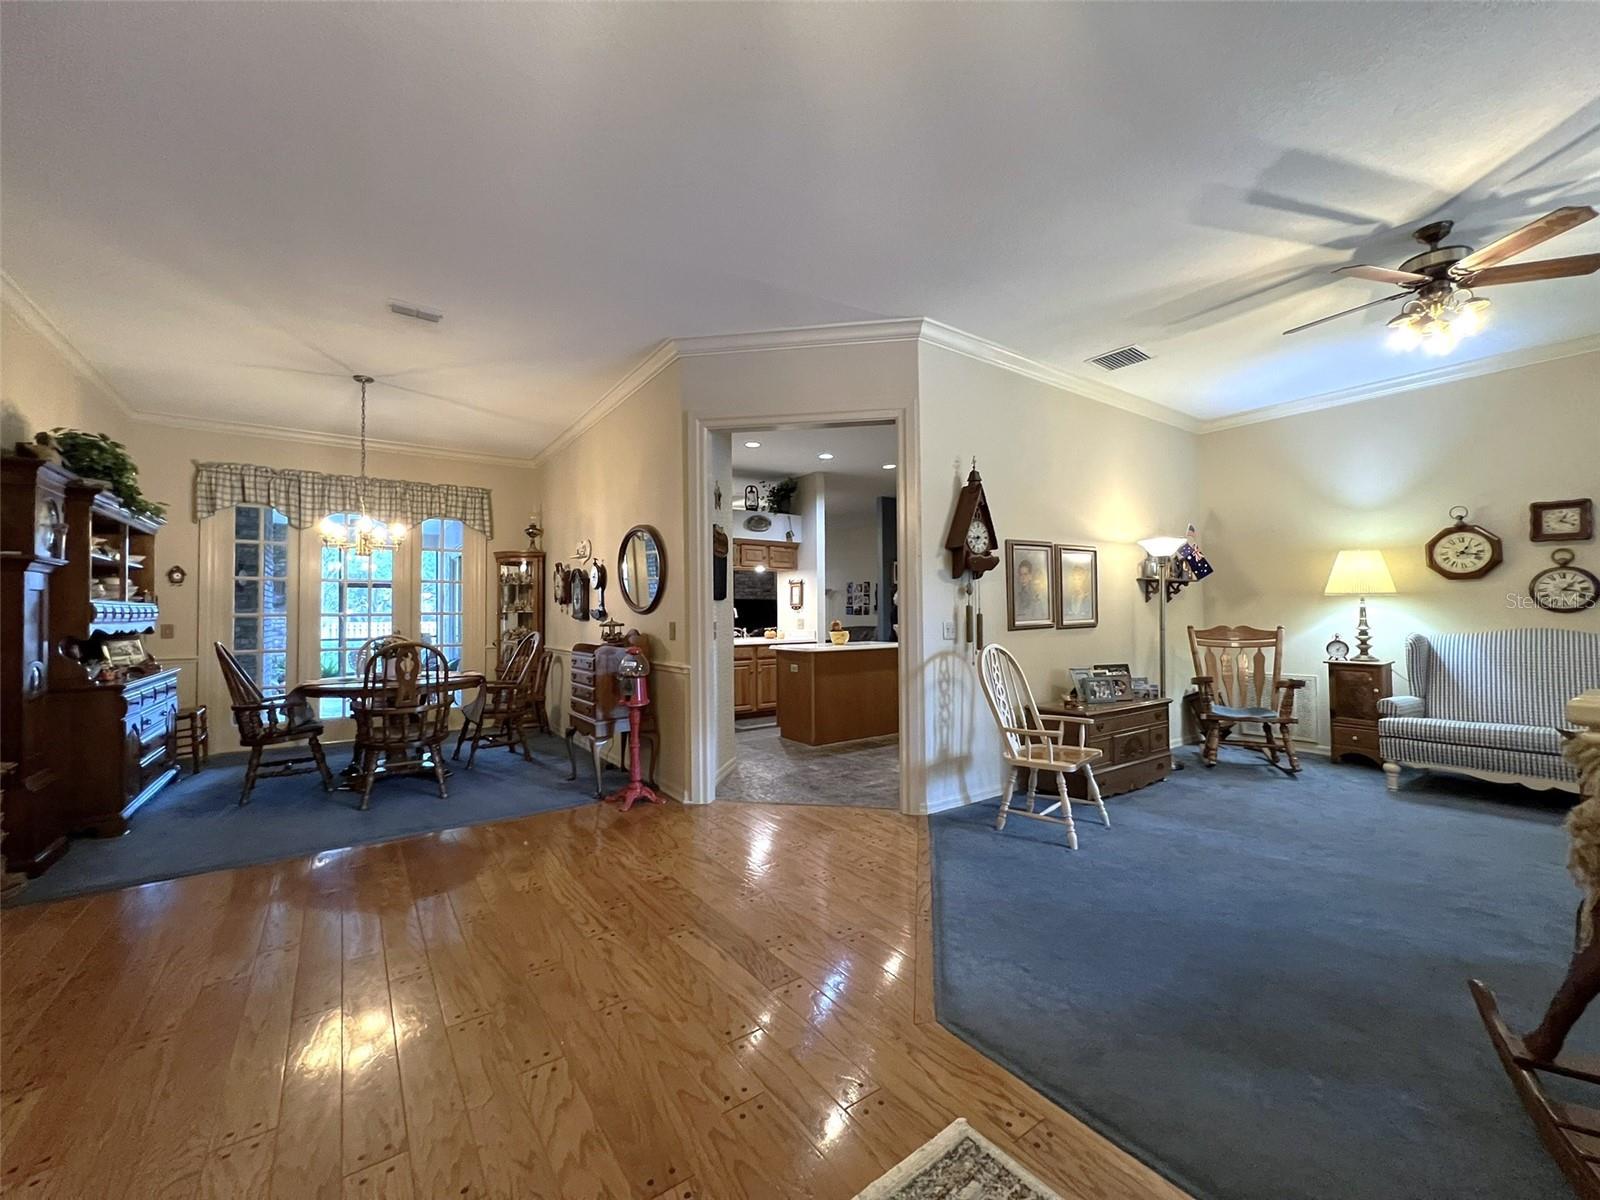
1189 354 1600 704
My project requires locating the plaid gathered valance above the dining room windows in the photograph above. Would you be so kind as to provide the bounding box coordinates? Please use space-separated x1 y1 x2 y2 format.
195 462 494 538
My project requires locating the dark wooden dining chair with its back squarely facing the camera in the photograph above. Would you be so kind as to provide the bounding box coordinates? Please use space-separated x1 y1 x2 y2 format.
355 642 454 810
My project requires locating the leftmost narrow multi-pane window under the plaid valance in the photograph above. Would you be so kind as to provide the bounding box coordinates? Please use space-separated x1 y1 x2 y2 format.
229 504 290 696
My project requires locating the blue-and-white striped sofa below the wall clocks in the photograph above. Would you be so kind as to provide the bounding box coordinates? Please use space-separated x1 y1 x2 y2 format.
1378 629 1600 792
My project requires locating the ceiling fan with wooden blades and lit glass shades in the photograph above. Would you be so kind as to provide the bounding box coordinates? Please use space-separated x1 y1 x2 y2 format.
1283 205 1600 354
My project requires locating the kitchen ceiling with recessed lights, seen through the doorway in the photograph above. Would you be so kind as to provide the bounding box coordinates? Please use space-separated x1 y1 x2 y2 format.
733 424 899 518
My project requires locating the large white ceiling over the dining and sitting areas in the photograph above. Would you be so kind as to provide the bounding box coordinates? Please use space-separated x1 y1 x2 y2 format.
0 3 1600 454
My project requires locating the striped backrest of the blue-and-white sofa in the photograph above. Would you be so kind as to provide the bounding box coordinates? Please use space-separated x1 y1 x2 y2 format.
1406 629 1600 728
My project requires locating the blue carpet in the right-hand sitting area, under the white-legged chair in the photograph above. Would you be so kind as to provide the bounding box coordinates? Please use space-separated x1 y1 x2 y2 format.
931 752 1597 1200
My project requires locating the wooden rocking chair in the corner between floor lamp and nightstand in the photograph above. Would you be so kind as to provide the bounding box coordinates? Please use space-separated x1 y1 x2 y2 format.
1189 626 1306 773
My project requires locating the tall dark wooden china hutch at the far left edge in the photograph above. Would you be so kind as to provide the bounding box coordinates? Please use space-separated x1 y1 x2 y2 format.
0 456 178 874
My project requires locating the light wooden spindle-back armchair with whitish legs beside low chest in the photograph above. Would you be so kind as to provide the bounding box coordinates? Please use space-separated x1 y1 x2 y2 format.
978 642 1110 850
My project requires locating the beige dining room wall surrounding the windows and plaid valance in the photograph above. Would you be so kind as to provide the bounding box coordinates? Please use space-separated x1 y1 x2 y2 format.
0 296 536 749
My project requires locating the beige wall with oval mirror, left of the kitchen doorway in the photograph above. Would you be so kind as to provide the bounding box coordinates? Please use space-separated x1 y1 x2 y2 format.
534 365 690 797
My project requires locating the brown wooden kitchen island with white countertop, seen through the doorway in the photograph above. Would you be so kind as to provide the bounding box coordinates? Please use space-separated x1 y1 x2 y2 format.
776 642 899 746
